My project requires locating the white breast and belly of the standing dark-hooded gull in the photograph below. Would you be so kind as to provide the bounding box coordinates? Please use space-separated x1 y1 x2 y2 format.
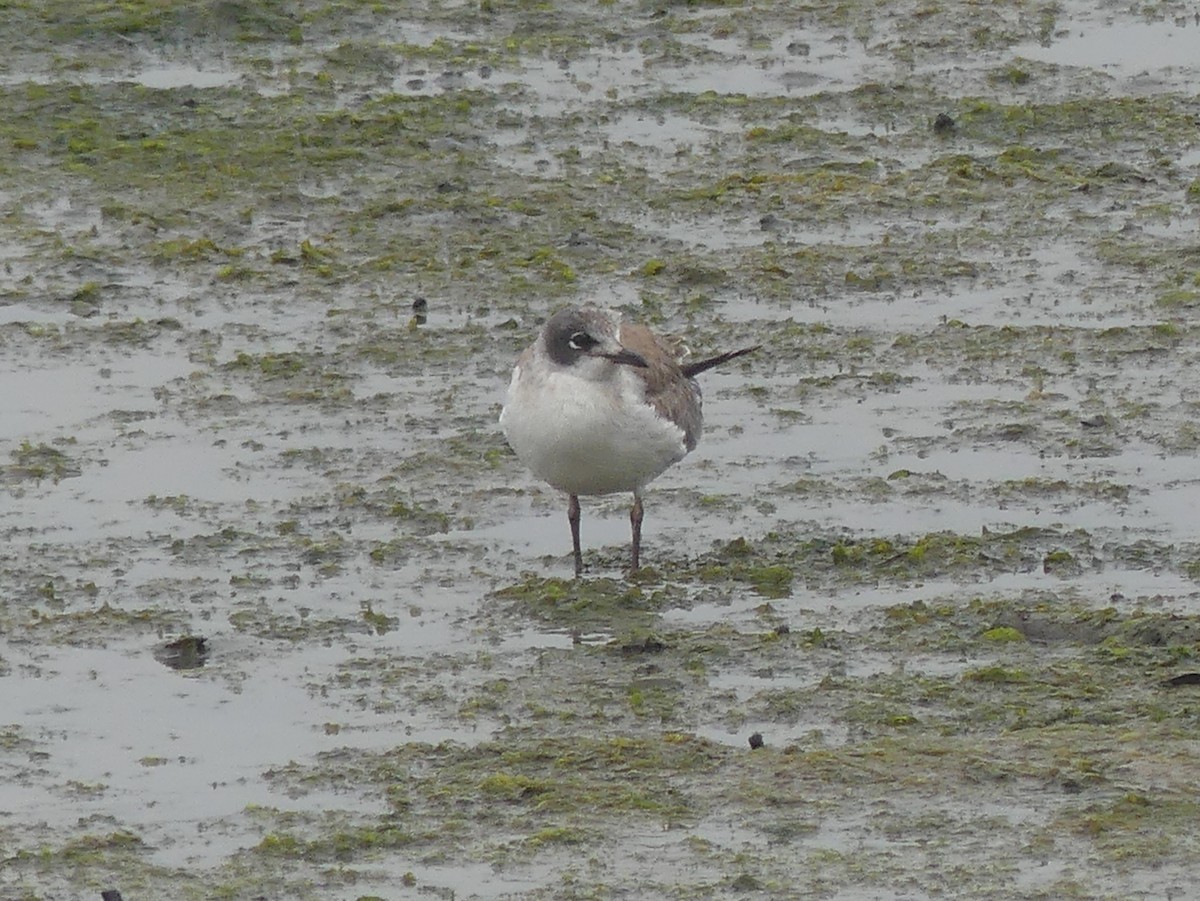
500 367 688 494
